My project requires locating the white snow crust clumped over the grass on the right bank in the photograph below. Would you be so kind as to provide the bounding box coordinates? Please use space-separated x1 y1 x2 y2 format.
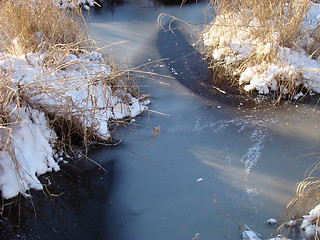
202 3 320 94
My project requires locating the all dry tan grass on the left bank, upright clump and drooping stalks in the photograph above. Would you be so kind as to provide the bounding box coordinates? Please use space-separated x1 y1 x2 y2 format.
0 0 138 149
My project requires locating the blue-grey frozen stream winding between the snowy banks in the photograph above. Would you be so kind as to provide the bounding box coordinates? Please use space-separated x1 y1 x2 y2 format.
2 0 320 240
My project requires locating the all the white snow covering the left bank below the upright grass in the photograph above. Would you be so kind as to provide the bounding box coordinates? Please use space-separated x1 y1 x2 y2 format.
0 49 149 199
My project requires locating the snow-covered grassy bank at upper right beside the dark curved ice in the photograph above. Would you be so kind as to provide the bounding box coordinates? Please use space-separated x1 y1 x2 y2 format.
203 0 320 98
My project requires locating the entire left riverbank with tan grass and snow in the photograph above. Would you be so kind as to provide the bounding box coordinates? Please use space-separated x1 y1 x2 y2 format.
0 0 149 199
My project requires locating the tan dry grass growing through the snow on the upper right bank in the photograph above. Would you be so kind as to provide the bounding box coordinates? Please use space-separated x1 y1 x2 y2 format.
204 0 320 98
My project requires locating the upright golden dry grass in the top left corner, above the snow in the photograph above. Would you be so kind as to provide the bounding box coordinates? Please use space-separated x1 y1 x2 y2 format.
0 0 87 55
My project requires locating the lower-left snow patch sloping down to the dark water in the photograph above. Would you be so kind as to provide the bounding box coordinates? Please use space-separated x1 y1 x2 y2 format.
0 107 59 199
